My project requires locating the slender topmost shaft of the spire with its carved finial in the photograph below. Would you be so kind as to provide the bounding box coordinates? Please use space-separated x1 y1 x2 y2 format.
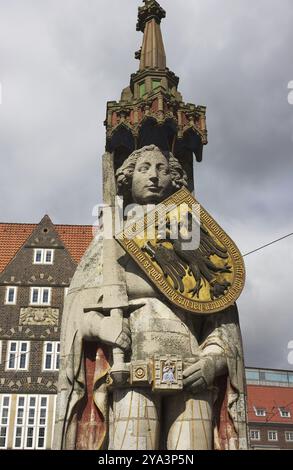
136 0 166 70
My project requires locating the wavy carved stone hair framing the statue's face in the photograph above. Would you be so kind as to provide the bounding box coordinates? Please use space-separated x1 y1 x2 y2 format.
116 145 188 195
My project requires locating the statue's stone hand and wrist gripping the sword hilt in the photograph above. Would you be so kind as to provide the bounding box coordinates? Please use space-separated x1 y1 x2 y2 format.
81 311 131 351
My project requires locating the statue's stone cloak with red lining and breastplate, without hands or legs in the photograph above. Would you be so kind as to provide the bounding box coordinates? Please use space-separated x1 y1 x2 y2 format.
54 238 247 450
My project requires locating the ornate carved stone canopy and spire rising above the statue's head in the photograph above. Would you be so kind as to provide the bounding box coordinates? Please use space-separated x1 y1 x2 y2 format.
105 0 207 191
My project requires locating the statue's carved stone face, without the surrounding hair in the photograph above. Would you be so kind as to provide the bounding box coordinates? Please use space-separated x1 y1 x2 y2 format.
132 150 172 204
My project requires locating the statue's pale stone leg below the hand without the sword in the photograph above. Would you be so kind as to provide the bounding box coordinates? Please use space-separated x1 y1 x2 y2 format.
164 392 213 450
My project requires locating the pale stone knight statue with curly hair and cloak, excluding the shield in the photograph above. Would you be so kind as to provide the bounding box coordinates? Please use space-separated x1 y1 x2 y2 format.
55 145 247 450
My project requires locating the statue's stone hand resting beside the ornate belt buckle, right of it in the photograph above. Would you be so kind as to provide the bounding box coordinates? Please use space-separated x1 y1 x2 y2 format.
183 356 216 393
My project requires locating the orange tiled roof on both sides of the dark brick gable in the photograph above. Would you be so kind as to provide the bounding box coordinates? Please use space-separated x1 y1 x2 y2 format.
0 223 93 272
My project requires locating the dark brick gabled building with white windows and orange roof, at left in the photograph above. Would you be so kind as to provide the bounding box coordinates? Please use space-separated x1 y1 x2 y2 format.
0 216 92 449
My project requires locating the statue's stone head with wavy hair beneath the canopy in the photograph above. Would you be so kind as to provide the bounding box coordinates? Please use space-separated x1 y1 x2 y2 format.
116 145 187 204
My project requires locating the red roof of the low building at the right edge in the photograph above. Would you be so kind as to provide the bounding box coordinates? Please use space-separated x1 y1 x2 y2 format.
247 385 293 425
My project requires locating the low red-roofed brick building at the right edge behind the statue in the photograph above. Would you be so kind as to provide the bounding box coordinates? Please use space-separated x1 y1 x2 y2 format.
246 368 293 450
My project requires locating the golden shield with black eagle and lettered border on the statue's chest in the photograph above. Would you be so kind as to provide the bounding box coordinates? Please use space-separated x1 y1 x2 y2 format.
115 188 245 314
